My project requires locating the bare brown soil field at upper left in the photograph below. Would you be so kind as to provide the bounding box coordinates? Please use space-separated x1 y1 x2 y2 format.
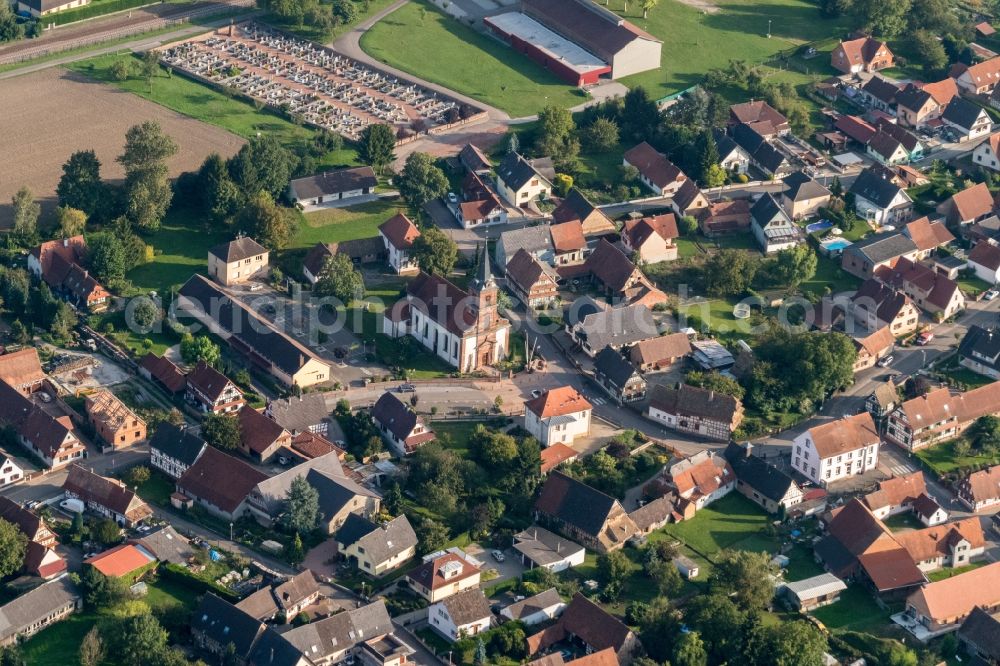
0 67 244 228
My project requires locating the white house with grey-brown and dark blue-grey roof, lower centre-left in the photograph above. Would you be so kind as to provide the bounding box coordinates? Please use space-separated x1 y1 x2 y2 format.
334 513 417 576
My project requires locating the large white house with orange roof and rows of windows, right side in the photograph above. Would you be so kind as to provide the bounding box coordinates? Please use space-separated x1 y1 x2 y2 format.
792 412 879 486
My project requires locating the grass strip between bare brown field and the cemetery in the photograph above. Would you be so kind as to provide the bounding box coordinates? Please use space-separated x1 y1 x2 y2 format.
67 55 358 169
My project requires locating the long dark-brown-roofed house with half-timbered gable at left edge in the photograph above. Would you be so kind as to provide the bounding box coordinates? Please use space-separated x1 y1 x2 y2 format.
0 381 87 469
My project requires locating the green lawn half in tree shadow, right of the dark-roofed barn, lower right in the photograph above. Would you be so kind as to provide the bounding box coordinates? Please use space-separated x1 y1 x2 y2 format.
664 492 777 557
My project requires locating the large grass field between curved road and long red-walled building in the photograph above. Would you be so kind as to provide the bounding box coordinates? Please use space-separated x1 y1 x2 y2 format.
361 2 586 116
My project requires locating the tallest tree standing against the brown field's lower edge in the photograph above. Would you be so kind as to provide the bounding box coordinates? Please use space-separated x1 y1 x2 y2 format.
117 120 177 231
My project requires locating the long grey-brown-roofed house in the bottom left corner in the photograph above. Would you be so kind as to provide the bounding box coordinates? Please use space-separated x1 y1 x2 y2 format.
0 576 83 647
